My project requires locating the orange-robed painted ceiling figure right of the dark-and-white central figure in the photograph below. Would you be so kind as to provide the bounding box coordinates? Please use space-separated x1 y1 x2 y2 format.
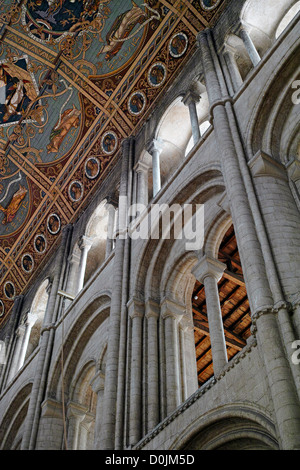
47 105 80 153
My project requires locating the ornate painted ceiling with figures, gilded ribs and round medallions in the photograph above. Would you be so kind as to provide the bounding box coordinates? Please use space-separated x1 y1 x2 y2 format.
0 0 226 325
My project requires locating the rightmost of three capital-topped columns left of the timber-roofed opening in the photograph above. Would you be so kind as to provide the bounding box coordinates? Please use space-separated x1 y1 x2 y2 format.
161 299 185 415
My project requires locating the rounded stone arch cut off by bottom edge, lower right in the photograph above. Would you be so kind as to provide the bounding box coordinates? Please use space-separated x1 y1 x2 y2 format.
169 402 279 450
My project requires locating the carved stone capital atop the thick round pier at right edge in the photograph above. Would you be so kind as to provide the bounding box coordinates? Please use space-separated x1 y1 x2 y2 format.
248 150 288 181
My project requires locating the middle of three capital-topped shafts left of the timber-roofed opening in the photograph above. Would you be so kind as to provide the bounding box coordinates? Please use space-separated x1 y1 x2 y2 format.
145 300 159 432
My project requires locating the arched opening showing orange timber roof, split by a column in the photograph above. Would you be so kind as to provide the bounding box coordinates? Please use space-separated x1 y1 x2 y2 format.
192 225 251 387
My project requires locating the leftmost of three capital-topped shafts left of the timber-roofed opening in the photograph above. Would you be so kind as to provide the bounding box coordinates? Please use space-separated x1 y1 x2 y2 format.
127 299 144 445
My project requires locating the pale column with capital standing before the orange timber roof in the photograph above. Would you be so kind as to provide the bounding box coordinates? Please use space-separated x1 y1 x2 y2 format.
193 256 228 376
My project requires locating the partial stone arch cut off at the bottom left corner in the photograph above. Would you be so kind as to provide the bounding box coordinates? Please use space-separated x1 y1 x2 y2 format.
0 383 32 450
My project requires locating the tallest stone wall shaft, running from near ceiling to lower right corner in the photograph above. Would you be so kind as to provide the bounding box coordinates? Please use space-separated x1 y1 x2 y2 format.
198 30 300 449
